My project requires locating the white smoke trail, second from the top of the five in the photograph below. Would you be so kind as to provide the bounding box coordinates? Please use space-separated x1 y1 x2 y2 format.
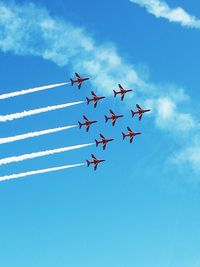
0 101 84 122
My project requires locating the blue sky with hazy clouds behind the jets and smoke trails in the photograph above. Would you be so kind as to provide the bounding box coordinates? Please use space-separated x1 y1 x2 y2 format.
0 0 200 267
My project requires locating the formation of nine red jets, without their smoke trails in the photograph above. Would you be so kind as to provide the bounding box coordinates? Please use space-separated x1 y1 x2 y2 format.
70 72 151 171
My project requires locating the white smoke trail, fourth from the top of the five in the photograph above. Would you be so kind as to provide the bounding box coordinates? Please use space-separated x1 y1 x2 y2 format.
0 143 94 165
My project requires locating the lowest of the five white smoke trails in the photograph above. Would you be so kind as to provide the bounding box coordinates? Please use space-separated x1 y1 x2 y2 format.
0 163 85 182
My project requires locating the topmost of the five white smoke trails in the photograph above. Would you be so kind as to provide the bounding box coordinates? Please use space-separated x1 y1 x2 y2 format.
0 82 69 100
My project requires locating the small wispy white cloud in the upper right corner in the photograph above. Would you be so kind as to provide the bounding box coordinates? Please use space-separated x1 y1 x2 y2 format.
129 0 200 29
